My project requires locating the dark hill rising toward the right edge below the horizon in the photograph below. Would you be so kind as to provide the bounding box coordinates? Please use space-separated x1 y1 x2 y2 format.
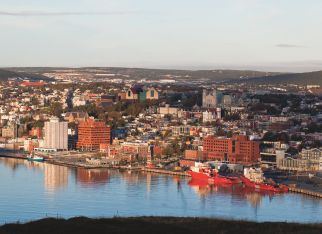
229 71 322 86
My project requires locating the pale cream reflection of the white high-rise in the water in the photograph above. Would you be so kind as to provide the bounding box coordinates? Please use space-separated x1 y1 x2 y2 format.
43 163 68 191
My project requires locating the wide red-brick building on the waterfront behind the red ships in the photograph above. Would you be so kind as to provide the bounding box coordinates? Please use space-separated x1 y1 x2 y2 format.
203 135 260 165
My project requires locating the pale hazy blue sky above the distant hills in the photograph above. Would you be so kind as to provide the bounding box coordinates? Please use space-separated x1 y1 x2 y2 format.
0 0 322 72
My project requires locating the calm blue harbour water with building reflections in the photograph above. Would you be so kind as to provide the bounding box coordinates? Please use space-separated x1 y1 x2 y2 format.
0 159 322 223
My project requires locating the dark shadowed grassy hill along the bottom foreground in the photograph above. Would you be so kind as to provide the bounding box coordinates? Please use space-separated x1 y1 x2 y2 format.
0 217 322 234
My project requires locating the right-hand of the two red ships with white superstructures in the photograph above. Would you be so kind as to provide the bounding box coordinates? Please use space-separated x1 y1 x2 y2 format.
240 168 288 193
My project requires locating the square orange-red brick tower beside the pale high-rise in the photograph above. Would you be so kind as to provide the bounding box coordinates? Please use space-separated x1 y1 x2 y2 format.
76 119 111 151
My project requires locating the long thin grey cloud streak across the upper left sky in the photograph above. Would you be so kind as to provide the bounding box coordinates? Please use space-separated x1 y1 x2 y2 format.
0 11 138 17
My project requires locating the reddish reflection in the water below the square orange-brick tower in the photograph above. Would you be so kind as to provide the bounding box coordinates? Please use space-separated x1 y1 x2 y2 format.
76 168 108 184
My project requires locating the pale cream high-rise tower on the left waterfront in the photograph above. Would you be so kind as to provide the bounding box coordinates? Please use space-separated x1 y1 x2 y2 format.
44 117 68 150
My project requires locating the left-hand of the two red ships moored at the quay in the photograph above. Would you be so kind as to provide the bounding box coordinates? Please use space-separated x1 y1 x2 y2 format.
188 163 241 185
